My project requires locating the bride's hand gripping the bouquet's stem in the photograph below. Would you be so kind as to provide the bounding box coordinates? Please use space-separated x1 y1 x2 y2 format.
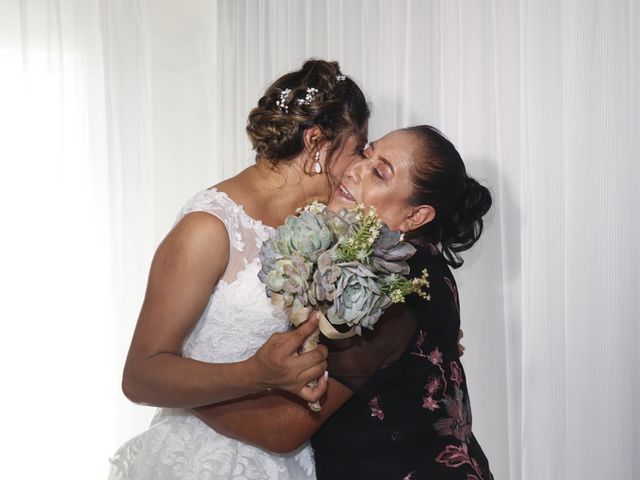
247 314 327 402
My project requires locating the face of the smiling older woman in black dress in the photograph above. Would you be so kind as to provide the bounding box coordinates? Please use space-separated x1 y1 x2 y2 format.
329 130 430 231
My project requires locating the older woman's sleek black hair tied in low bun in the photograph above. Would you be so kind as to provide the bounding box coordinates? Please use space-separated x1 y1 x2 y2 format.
404 125 491 268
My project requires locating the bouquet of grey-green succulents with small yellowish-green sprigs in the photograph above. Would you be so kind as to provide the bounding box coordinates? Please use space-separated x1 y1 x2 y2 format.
258 202 429 411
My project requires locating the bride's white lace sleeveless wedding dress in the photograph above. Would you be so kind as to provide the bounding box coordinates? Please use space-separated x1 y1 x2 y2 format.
110 189 315 480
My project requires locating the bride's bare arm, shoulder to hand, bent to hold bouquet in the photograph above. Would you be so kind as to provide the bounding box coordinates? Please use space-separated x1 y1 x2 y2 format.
122 212 326 408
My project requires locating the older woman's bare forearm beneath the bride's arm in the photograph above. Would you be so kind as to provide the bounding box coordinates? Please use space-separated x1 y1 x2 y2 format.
193 379 353 453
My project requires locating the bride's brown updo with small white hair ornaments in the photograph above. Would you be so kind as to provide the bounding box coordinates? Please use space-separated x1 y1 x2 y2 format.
247 60 370 165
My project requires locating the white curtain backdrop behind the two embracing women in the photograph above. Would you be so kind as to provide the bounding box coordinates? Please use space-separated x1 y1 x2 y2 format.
0 0 640 480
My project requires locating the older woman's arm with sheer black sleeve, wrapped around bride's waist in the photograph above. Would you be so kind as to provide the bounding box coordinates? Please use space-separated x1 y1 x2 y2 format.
193 304 418 453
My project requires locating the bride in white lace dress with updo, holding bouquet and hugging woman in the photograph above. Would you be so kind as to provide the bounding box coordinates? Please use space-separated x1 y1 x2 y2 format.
110 60 369 480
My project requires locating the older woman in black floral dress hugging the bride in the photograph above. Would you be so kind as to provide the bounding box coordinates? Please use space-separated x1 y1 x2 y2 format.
196 126 492 480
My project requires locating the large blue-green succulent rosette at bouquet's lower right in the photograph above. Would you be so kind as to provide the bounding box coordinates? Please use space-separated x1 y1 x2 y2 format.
327 263 391 333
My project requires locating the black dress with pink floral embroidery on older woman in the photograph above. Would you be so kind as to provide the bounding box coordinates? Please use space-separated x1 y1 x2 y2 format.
312 245 493 480
